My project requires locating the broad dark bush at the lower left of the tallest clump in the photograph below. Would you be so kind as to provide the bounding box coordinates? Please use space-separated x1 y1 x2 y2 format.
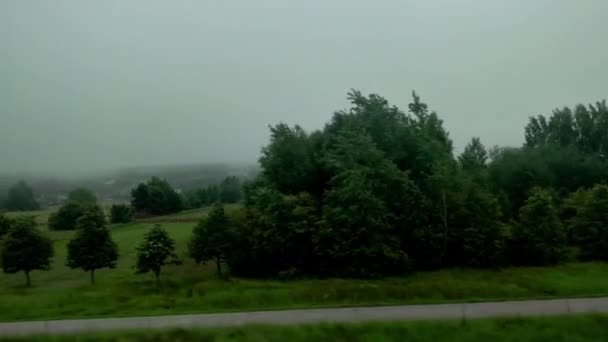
227 185 319 276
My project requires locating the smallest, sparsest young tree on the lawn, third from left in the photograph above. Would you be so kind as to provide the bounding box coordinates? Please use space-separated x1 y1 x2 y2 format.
135 224 179 284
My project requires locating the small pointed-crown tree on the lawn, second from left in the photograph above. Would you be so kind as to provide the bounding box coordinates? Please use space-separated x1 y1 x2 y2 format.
67 210 118 284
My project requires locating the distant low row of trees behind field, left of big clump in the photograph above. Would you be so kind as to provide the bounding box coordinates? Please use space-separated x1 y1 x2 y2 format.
182 176 243 209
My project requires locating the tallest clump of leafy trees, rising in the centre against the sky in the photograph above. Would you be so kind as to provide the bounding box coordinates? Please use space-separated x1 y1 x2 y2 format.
236 91 452 277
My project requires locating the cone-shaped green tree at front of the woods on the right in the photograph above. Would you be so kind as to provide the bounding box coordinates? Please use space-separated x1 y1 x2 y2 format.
511 188 566 265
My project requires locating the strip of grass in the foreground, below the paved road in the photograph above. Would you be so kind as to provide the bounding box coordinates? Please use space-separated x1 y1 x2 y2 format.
8 315 608 342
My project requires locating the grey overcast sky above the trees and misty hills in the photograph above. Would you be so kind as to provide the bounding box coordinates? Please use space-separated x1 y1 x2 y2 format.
0 0 608 173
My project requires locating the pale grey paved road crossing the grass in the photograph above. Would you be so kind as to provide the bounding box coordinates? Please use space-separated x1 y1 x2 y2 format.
0 297 608 336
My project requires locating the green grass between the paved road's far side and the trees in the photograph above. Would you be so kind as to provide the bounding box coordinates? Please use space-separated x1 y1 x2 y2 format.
0 208 608 321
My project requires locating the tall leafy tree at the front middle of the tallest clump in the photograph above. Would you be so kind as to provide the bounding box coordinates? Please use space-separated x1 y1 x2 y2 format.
316 132 418 276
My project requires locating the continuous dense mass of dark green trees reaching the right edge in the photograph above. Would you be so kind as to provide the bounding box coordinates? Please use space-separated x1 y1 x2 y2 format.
184 91 608 277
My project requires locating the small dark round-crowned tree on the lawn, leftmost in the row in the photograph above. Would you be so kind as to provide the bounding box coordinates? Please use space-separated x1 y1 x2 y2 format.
0 217 53 287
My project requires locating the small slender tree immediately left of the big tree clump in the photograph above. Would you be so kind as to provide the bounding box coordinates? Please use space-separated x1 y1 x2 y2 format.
188 203 230 276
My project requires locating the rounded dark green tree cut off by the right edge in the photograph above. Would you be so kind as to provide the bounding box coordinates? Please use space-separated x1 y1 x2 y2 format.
569 185 608 261
